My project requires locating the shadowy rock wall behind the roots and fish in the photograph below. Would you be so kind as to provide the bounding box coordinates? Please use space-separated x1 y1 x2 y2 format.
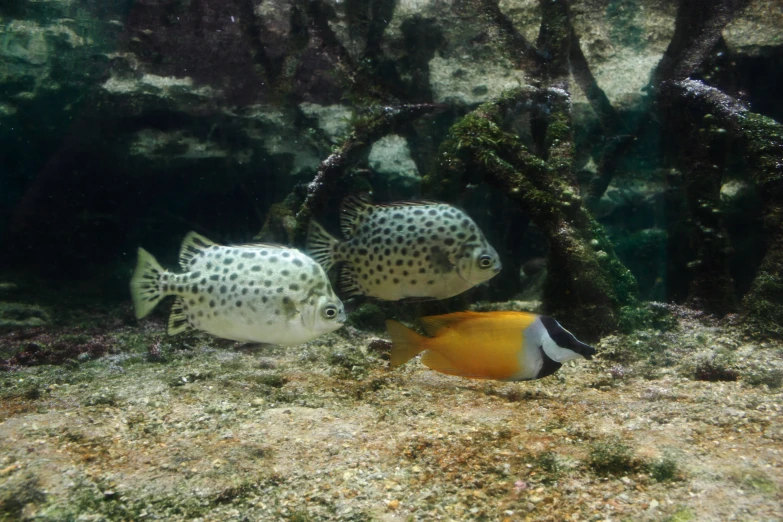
0 0 783 300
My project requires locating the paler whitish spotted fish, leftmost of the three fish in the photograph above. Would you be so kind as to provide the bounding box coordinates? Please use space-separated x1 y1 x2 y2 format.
130 232 345 346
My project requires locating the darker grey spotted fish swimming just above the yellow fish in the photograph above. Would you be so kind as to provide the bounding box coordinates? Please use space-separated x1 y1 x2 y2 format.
307 195 501 301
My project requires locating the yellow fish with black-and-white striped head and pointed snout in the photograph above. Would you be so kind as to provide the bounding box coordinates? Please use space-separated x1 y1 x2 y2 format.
386 312 595 381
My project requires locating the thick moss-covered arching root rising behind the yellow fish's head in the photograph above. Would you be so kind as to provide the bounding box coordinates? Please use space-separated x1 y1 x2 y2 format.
424 87 645 340
